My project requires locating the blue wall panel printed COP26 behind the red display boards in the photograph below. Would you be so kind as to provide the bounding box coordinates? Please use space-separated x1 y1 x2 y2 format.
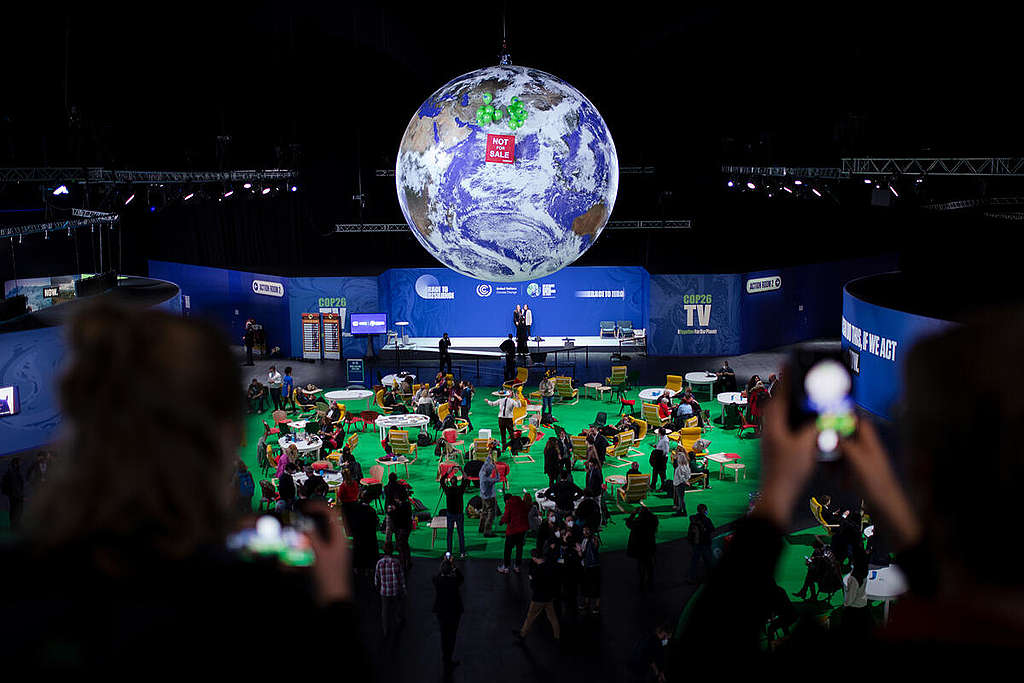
287 278 380 358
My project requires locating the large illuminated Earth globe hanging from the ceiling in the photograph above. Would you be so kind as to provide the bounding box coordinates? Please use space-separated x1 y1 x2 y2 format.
395 66 618 282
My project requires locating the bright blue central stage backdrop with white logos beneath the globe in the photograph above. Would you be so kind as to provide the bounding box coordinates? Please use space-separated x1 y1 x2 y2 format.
380 266 650 338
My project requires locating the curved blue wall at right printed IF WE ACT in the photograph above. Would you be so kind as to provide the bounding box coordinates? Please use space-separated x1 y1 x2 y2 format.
842 280 955 420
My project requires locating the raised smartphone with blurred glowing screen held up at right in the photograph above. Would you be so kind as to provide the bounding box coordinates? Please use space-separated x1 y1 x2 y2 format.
790 351 857 461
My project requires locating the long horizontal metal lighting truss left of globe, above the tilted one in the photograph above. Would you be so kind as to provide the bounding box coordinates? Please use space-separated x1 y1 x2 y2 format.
0 167 298 184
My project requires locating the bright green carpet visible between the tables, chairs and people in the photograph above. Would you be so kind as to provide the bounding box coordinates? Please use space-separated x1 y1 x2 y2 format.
241 385 765 561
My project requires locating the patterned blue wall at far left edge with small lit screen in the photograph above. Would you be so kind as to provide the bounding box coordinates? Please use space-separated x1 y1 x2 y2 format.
0 328 66 456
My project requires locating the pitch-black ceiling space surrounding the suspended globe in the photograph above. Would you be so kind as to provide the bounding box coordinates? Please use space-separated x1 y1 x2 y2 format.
0 2 1024 286
